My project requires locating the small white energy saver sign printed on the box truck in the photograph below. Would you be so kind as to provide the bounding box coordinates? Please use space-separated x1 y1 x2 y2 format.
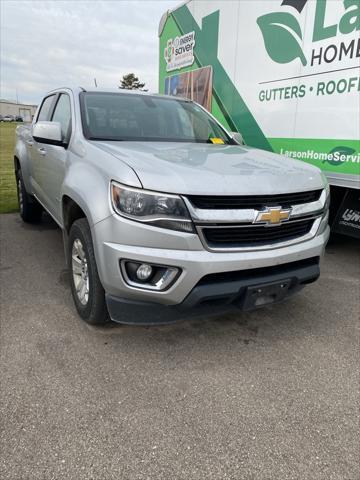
164 32 195 72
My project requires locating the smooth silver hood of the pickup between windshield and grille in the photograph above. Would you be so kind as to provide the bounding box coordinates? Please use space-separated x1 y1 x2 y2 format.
94 142 324 195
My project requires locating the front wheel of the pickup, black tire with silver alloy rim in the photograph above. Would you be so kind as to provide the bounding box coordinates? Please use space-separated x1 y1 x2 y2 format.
68 218 109 325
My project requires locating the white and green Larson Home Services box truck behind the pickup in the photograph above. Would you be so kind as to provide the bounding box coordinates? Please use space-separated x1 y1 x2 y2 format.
159 0 360 237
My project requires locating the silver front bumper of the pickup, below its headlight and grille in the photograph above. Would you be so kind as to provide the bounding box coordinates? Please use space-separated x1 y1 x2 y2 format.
92 216 329 323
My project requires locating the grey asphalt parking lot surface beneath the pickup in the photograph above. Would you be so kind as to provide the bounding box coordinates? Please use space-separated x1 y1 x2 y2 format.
0 215 360 480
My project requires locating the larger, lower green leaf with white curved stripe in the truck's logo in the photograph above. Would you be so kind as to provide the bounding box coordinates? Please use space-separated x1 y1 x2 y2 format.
257 12 307 66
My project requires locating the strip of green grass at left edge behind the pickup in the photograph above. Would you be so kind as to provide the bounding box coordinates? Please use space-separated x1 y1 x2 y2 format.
0 122 18 213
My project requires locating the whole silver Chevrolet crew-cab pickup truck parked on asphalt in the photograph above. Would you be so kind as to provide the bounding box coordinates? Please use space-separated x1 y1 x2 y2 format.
14 88 329 324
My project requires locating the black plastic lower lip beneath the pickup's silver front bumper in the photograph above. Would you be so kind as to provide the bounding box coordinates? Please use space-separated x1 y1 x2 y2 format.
106 257 320 325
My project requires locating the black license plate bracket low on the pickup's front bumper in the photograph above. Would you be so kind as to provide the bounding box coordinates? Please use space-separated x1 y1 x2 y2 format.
243 278 291 310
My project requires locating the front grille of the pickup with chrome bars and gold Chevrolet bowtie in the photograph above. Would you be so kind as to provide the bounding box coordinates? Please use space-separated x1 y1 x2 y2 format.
183 189 327 251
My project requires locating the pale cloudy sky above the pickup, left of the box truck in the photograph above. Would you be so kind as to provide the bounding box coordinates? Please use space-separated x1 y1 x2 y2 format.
0 0 182 104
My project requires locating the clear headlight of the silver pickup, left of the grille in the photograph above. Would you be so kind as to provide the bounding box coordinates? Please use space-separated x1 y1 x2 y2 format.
110 182 194 233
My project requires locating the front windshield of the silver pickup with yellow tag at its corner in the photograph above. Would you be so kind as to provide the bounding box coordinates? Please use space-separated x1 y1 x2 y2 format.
80 92 232 144
